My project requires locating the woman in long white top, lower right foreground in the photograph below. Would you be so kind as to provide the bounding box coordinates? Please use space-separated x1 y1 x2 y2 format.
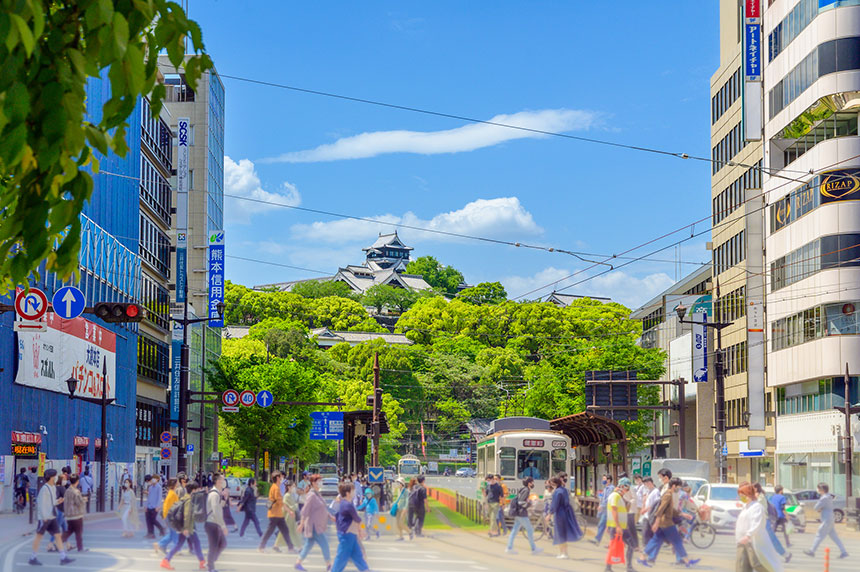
735 482 783 572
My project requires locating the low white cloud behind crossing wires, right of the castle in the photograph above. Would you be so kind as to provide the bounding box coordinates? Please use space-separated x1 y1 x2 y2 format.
501 266 675 310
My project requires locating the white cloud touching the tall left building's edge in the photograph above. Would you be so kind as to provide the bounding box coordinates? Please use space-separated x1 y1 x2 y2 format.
224 155 302 224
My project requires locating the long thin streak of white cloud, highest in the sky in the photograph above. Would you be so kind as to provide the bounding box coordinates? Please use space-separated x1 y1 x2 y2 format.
263 109 598 163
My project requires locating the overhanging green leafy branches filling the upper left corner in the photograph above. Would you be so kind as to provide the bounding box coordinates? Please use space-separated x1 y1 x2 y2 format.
0 0 212 292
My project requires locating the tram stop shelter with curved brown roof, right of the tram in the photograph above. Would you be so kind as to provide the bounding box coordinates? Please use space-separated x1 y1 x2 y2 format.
550 411 627 516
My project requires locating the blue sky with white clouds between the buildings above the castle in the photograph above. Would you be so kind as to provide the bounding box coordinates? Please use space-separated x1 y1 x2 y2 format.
200 0 718 307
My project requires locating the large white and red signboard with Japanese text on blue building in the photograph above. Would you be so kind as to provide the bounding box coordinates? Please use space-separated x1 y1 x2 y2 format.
15 312 116 399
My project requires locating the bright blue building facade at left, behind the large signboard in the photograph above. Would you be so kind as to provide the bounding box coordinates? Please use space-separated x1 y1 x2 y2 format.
0 72 141 492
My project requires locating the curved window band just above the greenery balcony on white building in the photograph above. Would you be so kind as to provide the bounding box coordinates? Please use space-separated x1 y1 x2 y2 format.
768 36 860 119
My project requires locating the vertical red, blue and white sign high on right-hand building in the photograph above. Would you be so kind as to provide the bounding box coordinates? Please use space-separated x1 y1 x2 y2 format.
743 0 764 141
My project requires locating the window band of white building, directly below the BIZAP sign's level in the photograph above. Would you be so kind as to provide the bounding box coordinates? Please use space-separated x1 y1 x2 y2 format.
770 234 860 292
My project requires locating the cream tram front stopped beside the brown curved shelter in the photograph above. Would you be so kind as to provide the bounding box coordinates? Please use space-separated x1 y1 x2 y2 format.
477 417 574 498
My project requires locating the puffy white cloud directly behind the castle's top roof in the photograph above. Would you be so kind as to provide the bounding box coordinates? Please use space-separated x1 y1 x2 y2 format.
291 197 543 243
